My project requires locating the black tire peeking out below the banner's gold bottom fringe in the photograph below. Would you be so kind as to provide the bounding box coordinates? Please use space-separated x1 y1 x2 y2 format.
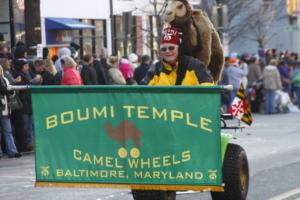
132 190 176 200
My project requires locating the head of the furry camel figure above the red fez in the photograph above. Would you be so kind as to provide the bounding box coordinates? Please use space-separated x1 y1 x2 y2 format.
163 0 192 26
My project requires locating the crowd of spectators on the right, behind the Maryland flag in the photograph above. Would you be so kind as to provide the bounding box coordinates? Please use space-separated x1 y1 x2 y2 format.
220 49 300 114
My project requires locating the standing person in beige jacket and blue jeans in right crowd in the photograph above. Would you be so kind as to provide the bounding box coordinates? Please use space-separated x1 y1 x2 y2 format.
263 59 282 114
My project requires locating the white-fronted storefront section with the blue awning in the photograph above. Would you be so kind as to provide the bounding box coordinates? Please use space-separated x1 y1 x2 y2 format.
40 0 111 55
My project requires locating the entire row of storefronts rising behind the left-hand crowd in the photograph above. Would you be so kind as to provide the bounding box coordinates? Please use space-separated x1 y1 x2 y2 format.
0 0 204 57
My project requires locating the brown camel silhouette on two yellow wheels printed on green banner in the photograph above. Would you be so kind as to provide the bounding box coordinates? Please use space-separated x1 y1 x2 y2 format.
104 120 142 149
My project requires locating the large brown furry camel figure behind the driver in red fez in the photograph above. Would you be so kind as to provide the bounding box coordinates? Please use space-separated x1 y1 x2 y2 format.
163 0 224 83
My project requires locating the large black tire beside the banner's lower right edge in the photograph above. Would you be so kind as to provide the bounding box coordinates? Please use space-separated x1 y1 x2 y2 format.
211 144 249 200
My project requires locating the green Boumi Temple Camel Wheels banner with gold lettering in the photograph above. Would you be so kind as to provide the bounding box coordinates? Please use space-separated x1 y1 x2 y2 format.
31 86 222 191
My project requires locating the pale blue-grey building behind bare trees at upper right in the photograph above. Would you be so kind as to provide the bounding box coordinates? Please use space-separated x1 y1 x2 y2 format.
228 0 300 55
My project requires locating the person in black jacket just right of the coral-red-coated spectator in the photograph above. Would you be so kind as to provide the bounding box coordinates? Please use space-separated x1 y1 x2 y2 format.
80 54 98 85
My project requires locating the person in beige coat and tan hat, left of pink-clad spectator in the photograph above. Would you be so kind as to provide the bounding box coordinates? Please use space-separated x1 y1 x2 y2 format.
107 56 126 85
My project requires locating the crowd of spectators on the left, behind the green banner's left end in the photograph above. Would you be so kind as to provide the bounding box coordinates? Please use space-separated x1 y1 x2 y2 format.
0 42 151 159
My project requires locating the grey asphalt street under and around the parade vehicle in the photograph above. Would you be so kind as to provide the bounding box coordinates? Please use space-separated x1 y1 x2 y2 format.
0 113 300 200
